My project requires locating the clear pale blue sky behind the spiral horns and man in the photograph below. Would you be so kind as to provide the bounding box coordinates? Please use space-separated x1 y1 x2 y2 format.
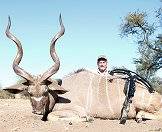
0 0 162 86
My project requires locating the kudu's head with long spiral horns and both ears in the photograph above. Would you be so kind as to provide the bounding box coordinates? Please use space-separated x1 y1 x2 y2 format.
4 14 67 120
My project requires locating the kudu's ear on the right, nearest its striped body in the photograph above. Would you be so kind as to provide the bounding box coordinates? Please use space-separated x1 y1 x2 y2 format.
48 79 68 94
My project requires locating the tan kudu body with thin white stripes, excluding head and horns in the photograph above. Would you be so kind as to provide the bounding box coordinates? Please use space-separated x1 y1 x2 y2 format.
48 70 162 122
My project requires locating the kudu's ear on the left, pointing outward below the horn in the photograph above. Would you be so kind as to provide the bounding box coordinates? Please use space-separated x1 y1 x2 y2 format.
3 83 28 94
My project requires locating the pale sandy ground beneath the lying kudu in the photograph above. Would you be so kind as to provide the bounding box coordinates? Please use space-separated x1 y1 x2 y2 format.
0 99 162 132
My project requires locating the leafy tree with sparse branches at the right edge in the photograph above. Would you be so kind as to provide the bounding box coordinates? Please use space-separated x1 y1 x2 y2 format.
121 11 162 79
